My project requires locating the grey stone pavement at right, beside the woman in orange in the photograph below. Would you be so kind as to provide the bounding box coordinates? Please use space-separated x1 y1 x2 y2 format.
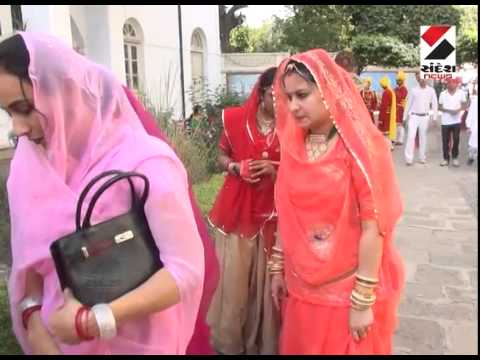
394 122 478 355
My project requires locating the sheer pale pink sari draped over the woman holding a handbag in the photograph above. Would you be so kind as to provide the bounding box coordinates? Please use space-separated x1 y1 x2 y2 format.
7 32 203 354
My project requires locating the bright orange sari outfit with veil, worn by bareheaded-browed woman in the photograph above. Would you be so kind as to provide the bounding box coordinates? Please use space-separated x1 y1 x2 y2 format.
274 50 404 354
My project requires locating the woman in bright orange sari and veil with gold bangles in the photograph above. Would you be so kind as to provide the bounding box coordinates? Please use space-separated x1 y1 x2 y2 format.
269 50 404 354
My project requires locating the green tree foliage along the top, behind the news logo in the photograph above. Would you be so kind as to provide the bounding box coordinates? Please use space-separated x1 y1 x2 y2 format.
276 5 466 66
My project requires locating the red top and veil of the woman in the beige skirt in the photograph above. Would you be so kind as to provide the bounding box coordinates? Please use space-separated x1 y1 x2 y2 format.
209 84 280 246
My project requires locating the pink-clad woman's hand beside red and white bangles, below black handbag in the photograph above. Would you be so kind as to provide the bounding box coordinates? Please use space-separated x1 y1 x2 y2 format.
48 289 82 345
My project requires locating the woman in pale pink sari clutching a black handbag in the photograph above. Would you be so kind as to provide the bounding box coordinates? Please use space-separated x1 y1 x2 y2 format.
0 33 210 354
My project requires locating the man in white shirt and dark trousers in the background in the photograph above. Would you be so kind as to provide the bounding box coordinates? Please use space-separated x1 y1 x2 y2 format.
438 79 467 166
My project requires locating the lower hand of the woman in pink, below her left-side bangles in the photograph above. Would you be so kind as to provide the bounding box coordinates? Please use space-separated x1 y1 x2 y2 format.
27 311 61 355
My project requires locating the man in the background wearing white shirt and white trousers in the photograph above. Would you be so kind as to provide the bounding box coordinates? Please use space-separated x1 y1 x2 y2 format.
404 72 438 165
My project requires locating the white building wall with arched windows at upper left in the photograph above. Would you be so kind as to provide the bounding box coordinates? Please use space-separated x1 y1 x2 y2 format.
0 5 222 147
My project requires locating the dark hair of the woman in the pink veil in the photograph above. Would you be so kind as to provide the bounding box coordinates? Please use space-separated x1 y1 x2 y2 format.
0 34 31 83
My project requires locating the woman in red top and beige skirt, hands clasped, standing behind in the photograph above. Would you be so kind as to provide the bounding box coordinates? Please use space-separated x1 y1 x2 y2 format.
208 68 280 354
